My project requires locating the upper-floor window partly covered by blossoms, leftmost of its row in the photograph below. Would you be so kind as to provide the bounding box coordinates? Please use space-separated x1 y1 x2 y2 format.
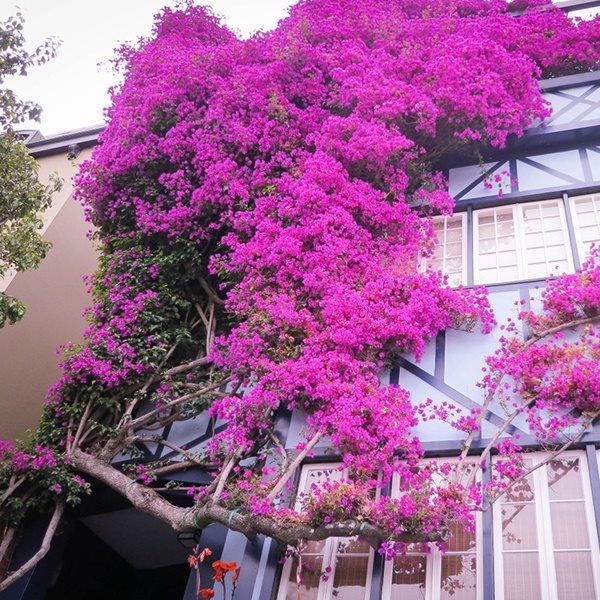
423 213 467 287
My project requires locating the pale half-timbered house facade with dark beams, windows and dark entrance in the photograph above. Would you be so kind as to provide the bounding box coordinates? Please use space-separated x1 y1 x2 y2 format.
0 0 600 600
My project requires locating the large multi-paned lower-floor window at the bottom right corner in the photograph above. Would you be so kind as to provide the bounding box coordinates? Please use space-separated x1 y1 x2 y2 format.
493 452 600 600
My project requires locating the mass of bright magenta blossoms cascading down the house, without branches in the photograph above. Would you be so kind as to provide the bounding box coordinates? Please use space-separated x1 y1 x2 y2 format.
3 0 600 553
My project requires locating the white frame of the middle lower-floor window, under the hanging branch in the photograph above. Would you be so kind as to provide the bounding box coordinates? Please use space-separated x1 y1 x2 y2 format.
381 458 483 600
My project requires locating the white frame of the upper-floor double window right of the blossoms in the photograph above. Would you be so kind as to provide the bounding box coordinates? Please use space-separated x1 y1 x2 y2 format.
473 198 575 286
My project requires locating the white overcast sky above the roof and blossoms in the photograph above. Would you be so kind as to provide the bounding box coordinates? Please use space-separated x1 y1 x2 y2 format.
0 0 293 135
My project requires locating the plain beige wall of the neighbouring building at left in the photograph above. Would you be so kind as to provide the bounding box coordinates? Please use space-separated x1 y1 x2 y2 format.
0 150 96 439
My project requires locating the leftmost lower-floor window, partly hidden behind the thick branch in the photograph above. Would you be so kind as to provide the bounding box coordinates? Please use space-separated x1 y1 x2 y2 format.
277 464 374 600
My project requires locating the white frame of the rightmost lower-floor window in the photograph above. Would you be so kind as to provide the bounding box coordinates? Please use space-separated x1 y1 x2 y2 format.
492 450 600 600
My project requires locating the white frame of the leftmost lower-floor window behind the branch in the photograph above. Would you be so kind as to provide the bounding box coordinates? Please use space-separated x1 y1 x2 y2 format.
277 463 375 600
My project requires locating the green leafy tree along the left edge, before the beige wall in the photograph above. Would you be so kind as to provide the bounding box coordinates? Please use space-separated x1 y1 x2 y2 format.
0 13 60 328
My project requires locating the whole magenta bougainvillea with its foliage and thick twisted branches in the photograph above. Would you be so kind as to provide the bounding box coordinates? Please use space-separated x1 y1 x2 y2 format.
0 0 600 589
